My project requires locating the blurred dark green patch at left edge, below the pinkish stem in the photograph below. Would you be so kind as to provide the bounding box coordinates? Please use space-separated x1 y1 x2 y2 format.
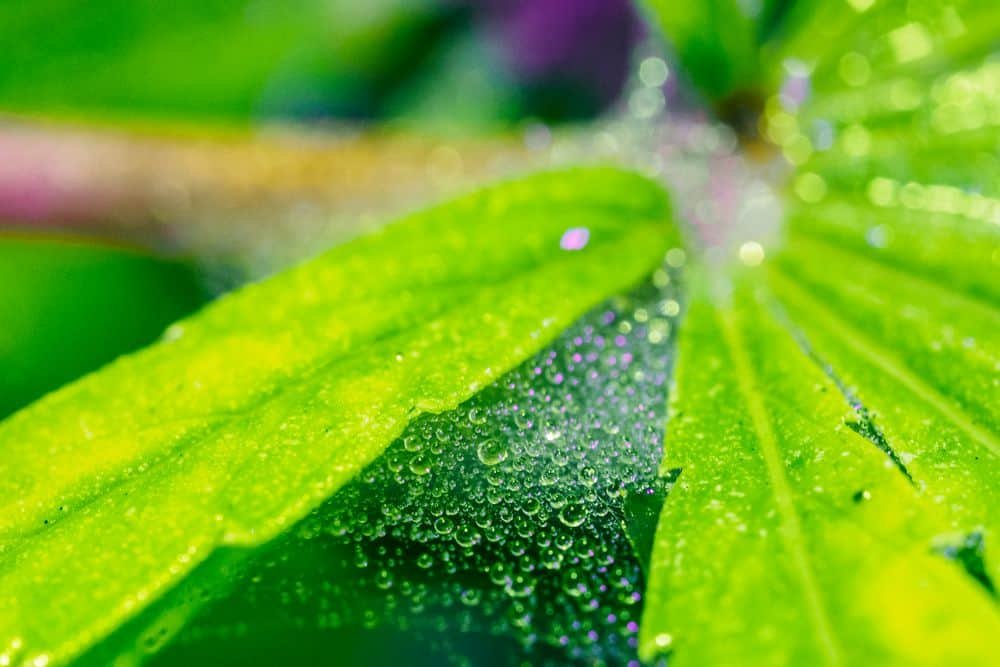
0 236 207 418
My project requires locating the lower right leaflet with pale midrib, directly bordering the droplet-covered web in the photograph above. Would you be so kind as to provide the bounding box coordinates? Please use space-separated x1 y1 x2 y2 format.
640 268 1000 666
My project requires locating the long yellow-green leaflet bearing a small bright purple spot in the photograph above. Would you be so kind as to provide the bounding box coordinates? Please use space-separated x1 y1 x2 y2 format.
0 169 677 665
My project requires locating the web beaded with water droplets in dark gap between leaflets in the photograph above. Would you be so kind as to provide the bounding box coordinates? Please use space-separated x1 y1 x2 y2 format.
154 269 681 664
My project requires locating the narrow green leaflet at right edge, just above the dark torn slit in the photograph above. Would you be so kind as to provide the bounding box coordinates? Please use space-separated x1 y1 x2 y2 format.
771 226 1000 578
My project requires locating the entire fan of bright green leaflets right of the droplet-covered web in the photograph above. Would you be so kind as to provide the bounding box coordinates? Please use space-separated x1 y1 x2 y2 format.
640 0 1000 665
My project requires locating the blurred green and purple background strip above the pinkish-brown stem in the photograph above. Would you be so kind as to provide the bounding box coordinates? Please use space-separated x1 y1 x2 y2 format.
0 0 640 128
